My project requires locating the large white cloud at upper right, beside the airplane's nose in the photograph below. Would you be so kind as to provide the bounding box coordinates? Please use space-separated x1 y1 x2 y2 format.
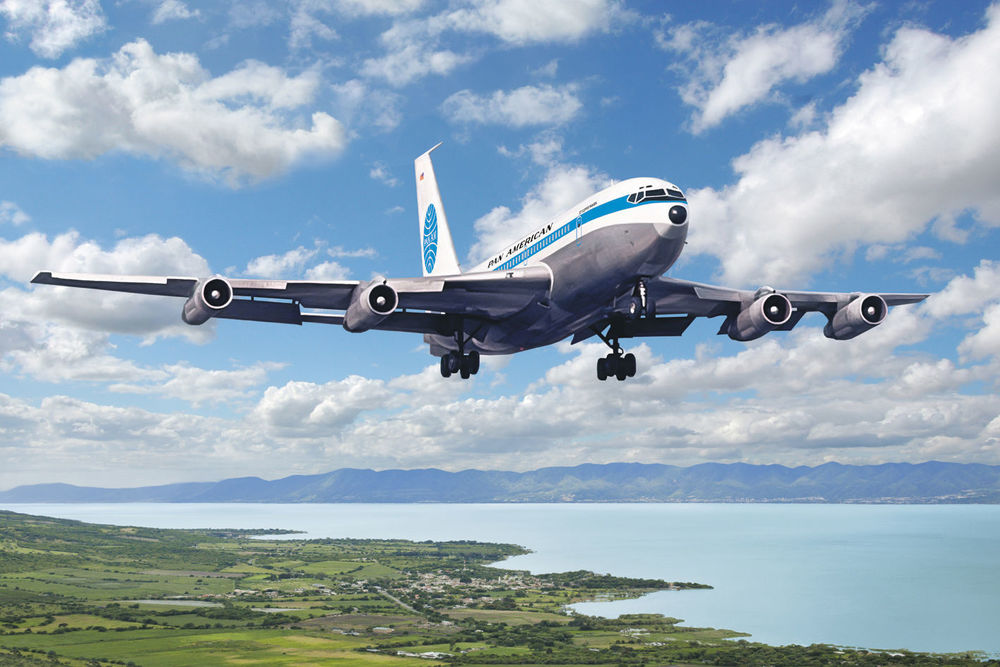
688 5 1000 285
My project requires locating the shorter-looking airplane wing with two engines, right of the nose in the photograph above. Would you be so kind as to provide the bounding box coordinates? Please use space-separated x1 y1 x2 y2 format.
647 277 929 340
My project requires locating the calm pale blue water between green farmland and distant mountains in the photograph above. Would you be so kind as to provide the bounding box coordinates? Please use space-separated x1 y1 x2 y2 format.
2 503 1000 657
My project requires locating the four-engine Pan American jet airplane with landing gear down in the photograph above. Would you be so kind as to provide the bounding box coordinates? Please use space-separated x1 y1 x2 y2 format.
31 144 928 381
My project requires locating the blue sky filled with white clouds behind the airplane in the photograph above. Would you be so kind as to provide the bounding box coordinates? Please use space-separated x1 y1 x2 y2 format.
0 0 1000 488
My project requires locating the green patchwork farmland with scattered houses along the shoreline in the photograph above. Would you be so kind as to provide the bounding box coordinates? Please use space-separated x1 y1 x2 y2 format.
0 511 998 667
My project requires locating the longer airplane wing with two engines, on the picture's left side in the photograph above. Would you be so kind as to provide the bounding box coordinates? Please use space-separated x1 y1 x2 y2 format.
31 266 552 333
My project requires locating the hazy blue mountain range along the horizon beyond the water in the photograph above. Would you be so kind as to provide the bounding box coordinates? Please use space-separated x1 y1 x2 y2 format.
0 461 1000 503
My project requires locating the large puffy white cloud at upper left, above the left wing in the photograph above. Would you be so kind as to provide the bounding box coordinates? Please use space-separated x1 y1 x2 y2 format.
0 40 347 185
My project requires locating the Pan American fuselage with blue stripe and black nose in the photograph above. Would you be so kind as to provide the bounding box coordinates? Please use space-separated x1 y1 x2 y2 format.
427 178 688 354
